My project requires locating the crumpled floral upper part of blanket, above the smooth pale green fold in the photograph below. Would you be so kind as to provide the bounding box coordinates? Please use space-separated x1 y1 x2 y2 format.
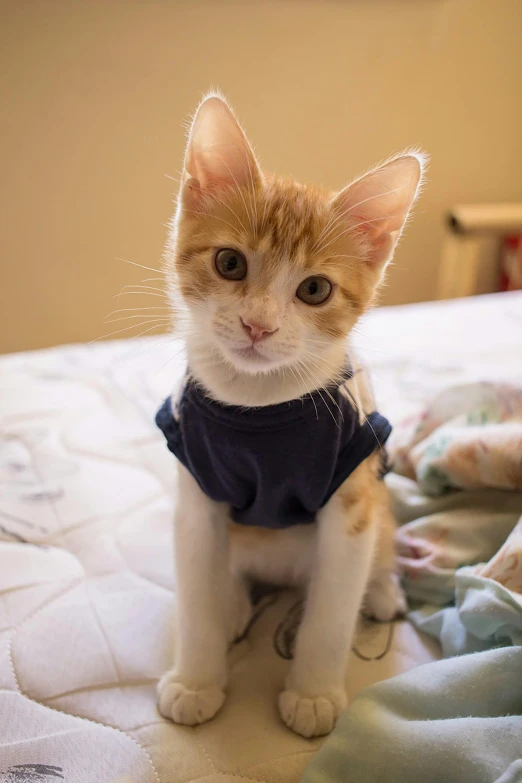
394 381 522 656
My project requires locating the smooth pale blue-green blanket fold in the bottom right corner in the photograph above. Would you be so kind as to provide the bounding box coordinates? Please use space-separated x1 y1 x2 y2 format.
302 647 522 783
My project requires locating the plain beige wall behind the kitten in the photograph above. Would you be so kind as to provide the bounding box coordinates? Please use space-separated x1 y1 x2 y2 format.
0 0 522 351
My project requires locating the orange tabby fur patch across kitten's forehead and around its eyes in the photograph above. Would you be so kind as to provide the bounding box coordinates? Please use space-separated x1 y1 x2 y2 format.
176 177 377 338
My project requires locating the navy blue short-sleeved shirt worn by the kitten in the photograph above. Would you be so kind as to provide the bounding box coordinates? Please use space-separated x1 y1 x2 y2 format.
156 376 391 529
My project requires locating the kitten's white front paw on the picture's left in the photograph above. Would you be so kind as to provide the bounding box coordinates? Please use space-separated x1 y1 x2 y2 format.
158 672 225 726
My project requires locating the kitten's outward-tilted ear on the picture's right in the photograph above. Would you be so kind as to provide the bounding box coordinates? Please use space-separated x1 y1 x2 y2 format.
333 152 427 270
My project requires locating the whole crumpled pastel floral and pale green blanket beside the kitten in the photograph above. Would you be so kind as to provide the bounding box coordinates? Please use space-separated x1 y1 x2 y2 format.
302 383 522 783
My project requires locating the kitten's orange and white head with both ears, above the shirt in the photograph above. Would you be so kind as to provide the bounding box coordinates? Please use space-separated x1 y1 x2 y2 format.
168 95 424 374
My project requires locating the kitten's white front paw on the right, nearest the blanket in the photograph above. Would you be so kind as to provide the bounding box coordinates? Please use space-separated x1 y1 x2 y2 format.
279 690 346 738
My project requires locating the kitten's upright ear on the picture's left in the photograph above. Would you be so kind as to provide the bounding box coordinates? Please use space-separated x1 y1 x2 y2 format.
181 95 262 208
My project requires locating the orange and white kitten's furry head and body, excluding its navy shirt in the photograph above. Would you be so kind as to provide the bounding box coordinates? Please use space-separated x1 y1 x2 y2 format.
158 95 424 737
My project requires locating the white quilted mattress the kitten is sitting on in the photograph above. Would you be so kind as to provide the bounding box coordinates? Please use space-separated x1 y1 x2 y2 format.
0 294 522 783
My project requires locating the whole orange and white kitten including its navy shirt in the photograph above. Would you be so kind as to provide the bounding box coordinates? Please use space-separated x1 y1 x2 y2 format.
157 95 424 737
